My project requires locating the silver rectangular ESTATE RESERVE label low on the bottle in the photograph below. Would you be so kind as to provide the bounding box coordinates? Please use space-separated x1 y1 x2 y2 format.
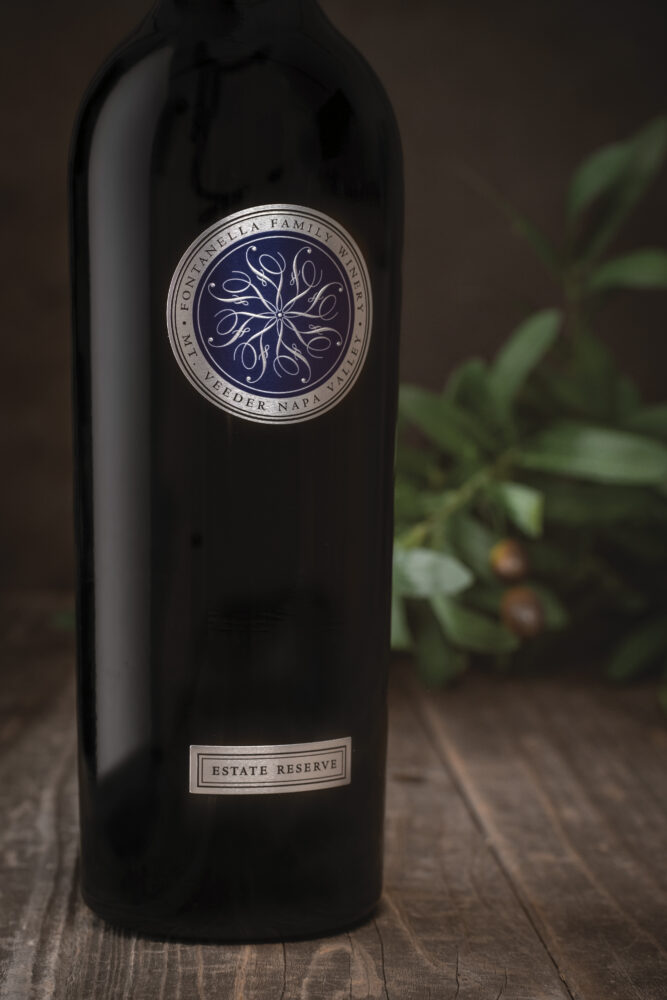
190 737 352 795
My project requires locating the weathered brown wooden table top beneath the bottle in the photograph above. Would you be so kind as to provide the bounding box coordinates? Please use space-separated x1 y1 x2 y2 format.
0 594 667 1000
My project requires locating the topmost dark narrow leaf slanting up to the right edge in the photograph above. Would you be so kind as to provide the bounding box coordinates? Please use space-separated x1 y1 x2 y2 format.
582 117 667 260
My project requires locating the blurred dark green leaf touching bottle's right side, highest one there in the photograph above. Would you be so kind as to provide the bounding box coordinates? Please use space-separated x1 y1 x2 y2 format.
399 385 494 459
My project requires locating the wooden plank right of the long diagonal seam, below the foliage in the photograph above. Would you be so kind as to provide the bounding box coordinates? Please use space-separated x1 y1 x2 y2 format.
415 679 667 1000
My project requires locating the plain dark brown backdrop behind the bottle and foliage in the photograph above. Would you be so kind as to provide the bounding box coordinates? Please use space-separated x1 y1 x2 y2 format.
0 0 667 590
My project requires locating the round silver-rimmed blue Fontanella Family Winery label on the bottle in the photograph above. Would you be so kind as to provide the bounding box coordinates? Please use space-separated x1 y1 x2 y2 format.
167 205 372 424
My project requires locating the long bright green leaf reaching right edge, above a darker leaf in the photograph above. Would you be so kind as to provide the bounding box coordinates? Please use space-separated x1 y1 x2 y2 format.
516 423 667 485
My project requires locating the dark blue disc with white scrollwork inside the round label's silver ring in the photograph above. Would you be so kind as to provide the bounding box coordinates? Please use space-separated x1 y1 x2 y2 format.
193 234 353 398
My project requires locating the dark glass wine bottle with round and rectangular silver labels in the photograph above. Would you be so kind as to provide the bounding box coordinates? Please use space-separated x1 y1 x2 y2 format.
70 0 402 941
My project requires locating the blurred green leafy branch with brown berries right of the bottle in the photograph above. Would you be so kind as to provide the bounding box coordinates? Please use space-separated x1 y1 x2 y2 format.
392 118 667 705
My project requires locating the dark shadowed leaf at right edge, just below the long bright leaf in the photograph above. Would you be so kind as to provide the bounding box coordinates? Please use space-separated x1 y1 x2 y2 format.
544 481 667 527
